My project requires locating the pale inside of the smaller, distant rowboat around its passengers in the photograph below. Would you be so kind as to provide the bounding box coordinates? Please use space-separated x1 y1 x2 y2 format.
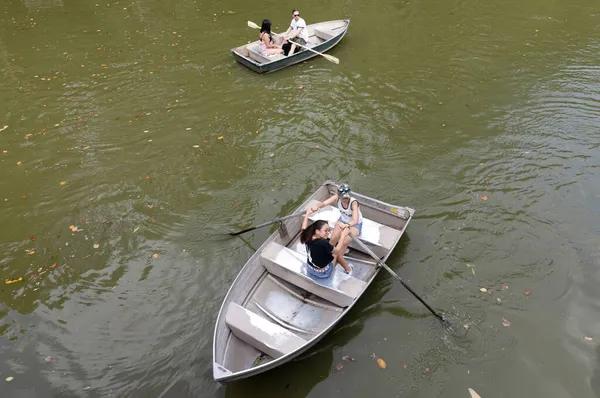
235 21 348 64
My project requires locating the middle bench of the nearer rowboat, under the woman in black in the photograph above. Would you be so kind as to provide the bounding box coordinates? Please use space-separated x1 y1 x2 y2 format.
260 242 366 307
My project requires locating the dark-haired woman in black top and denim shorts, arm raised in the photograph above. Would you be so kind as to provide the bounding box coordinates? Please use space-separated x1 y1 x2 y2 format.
300 209 351 278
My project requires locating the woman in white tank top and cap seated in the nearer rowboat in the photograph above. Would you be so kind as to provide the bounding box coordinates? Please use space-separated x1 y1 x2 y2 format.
311 184 362 268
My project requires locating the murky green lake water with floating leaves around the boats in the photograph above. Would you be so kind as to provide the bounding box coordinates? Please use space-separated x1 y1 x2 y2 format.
0 0 600 398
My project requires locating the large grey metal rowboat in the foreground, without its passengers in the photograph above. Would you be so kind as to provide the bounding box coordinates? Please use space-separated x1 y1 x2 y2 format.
213 181 415 383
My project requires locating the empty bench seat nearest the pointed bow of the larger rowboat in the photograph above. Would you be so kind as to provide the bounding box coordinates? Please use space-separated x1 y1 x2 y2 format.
225 303 306 358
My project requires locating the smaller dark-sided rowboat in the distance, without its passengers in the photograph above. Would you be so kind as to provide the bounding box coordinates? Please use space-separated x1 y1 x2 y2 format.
231 19 350 73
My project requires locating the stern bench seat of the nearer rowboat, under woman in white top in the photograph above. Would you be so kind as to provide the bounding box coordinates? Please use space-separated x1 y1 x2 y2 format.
307 200 402 258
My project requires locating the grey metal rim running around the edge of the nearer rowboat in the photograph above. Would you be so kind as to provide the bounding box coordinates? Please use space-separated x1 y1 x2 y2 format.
213 180 415 383
